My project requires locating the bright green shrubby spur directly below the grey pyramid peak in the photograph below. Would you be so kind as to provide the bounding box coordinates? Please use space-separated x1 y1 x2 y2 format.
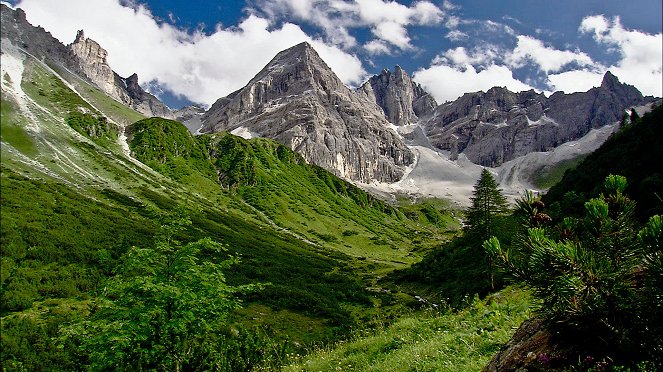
128 118 458 273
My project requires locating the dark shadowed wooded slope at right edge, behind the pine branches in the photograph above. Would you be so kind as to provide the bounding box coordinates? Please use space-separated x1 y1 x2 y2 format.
543 105 663 222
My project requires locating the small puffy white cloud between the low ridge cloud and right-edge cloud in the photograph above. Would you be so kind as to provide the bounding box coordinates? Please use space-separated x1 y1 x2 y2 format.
506 35 594 73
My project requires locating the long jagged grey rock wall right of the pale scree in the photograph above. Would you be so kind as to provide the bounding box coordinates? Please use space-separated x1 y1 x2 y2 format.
423 72 651 167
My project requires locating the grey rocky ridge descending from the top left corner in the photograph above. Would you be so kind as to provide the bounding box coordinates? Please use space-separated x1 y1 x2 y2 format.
0 4 174 118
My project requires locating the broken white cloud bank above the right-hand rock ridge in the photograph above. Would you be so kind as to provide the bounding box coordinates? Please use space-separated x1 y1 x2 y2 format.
414 15 663 102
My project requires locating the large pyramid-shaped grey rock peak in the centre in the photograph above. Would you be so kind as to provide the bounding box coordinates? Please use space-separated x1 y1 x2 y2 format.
200 43 414 182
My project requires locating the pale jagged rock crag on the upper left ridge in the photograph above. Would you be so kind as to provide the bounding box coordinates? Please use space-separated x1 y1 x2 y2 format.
69 30 175 119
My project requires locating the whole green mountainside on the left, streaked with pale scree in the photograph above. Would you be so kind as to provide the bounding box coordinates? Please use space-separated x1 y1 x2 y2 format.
0 7 458 370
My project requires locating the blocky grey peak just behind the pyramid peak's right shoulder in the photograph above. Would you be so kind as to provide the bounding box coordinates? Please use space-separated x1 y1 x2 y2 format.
358 65 437 125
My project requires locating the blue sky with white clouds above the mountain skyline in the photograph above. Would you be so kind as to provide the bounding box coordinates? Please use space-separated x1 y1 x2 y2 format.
3 0 663 109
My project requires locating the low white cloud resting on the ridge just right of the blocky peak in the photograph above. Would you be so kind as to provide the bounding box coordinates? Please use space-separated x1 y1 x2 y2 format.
413 65 532 103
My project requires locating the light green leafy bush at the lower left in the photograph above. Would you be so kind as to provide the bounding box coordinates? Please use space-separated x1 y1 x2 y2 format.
61 212 254 370
